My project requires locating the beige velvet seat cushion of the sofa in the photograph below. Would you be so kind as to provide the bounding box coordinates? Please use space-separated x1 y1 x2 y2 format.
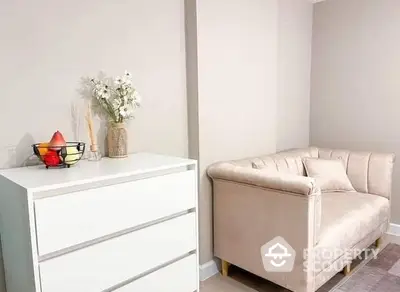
314 192 390 270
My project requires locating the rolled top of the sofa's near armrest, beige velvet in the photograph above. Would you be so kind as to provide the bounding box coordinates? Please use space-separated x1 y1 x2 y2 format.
207 162 319 196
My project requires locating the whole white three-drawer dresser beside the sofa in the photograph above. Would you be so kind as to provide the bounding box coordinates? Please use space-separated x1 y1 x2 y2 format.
0 153 199 292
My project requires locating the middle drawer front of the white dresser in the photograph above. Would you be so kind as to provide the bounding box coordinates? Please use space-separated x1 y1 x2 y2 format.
39 213 196 292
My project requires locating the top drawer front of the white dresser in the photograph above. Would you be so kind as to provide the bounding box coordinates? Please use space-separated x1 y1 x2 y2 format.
35 170 196 256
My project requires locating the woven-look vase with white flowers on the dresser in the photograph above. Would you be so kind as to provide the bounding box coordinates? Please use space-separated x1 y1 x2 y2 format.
91 71 140 158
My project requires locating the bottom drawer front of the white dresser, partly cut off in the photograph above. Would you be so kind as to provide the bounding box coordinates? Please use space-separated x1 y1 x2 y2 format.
115 255 199 292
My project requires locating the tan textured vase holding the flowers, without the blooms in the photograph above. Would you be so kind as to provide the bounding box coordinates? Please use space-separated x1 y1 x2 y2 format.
107 122 128 158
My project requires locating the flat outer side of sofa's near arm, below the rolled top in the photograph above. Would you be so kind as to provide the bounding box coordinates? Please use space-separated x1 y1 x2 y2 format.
210 177 321 291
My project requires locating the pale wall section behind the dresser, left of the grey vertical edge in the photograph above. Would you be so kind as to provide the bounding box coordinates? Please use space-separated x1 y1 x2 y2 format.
0 0 188 292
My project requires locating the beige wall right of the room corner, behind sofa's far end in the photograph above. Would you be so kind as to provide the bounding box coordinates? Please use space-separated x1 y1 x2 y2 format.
311 0 400 224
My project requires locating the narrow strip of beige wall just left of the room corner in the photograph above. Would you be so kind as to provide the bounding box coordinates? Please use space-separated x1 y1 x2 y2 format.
276 0 313 150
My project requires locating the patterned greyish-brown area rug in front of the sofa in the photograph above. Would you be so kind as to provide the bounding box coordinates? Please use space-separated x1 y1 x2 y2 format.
333 243 400 292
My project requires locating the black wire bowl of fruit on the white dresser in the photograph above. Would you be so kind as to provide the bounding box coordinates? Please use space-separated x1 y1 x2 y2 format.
32 142 85 168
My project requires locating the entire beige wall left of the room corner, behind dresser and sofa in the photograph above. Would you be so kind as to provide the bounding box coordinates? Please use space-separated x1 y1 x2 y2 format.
0 0 312 292
